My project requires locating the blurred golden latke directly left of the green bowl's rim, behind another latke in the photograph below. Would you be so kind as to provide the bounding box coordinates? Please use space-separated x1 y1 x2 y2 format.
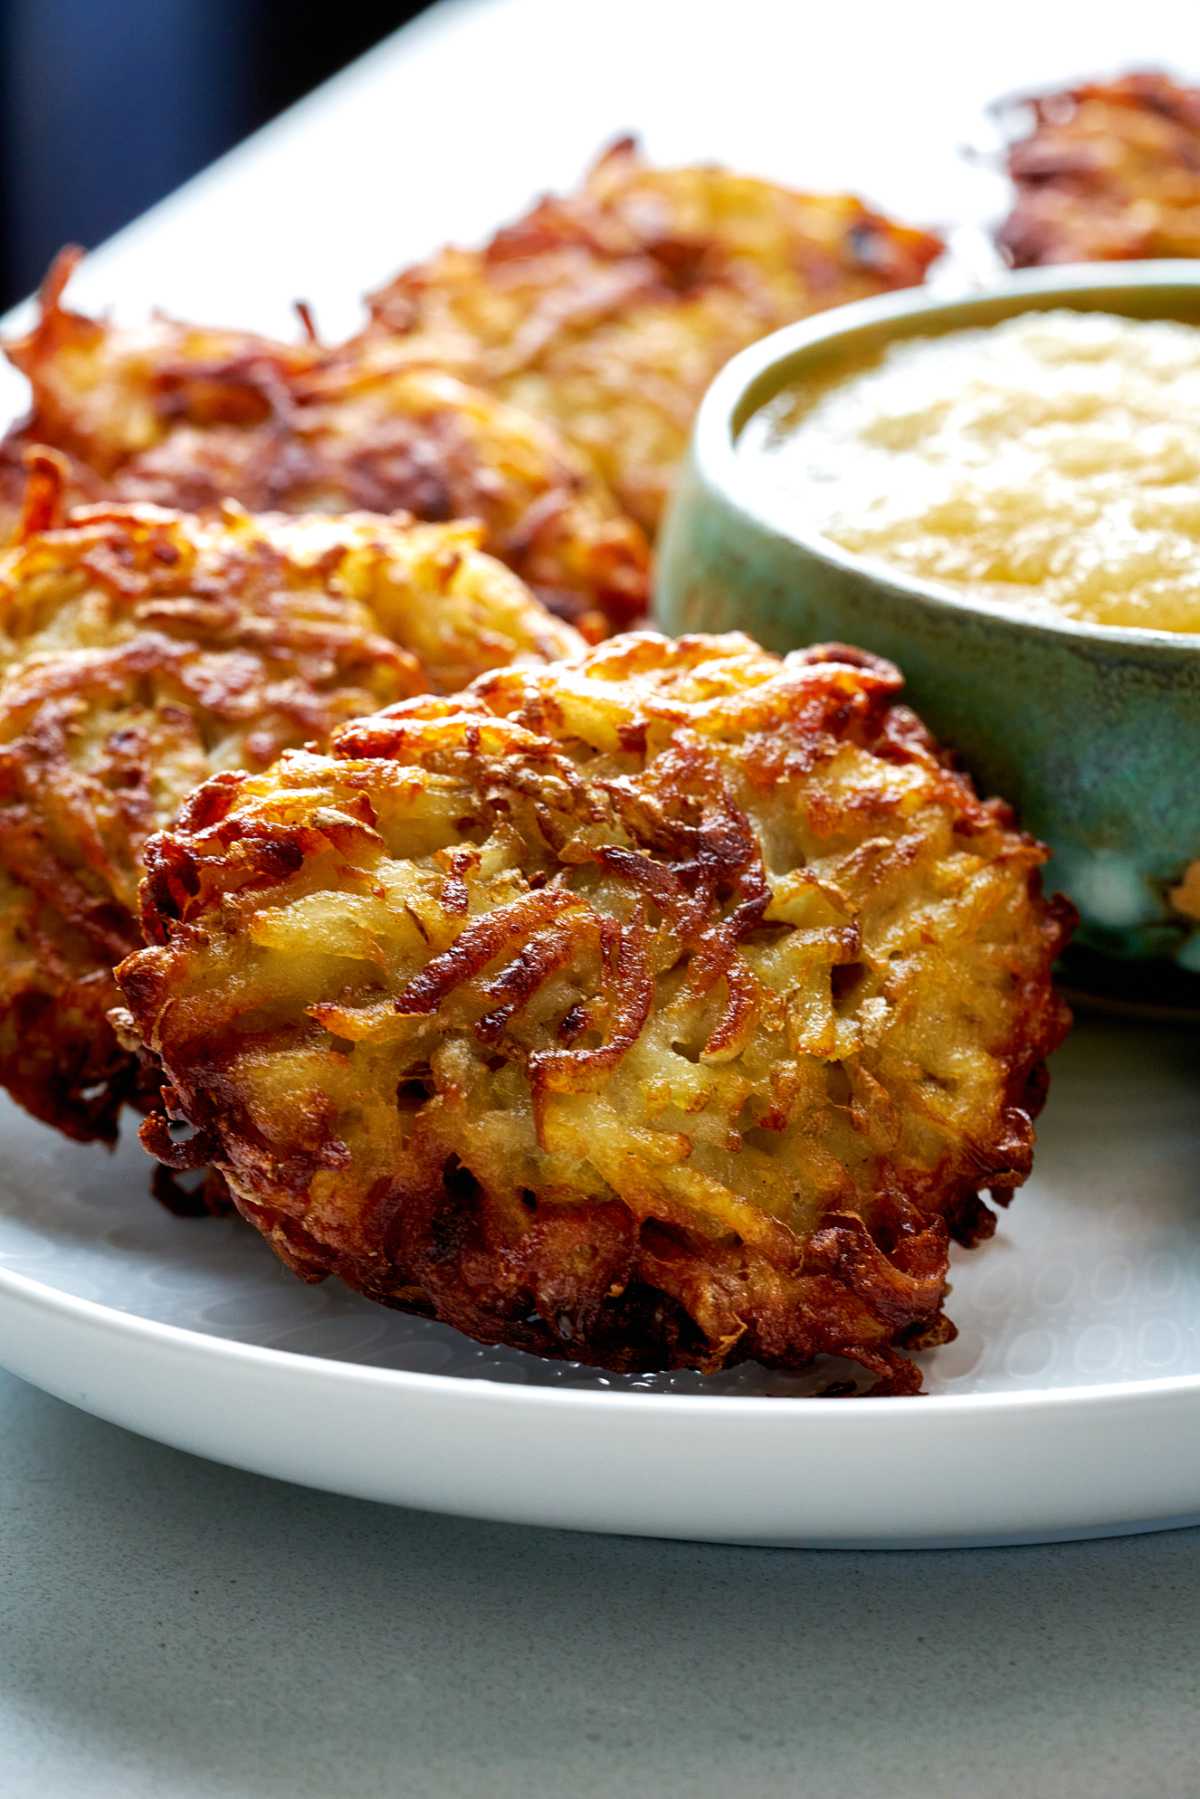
367 140 943 531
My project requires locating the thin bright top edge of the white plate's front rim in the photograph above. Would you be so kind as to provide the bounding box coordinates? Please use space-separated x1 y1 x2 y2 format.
0 1261 1200 1430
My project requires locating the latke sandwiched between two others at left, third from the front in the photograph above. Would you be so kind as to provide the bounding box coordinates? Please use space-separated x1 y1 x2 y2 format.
0 252 649 637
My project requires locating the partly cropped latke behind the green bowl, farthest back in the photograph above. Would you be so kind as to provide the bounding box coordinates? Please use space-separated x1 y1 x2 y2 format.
999 72 1200 266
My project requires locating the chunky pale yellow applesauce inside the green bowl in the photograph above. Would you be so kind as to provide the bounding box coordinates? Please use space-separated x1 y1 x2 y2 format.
739 311 1200 631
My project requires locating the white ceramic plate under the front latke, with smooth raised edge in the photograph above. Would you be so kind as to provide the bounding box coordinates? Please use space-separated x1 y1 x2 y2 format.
0 1020 1200 1547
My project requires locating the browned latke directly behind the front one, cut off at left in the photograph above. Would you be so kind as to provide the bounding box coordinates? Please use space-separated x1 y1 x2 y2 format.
0 492 581 1139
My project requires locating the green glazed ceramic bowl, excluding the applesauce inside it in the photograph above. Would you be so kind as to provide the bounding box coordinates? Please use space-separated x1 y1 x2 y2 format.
657 263 1200 1006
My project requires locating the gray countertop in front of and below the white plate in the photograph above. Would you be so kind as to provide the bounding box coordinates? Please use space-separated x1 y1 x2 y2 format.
0 1374 1200 1799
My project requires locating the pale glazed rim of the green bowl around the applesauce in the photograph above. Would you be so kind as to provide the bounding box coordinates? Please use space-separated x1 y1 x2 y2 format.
691 257 1200 660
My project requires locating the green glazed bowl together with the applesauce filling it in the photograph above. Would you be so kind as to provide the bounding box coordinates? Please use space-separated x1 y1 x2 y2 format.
657 263 1200 1006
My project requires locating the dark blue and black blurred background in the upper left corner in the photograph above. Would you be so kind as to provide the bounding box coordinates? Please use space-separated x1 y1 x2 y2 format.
0 0 423 304
